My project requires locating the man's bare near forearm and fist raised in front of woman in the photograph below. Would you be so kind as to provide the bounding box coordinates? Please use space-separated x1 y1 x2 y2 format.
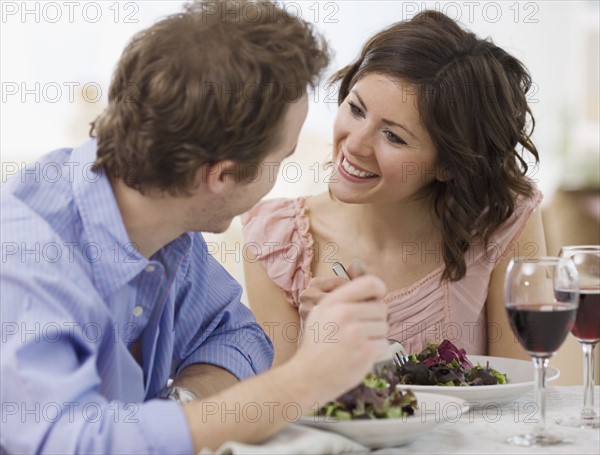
183 276 388 452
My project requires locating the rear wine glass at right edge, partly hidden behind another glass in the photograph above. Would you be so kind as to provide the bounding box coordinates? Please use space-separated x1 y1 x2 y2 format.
556 245 600 429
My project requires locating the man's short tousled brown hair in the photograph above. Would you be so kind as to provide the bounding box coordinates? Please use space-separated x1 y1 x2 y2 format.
90 0 329 194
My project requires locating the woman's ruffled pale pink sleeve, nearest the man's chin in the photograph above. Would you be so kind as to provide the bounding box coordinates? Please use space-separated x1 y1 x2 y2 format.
242 198 314 307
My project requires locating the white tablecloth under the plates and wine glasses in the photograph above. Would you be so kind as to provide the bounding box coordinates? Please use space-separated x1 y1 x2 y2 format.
202 386 600 455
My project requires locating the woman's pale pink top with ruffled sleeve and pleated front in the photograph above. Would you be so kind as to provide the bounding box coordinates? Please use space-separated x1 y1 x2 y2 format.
242 192 542 355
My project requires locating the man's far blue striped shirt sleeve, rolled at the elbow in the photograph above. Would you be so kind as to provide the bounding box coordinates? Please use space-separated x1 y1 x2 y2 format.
174 234 274 380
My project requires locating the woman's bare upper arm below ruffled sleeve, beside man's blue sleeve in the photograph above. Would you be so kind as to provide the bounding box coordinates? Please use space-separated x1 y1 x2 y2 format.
244 258 300 367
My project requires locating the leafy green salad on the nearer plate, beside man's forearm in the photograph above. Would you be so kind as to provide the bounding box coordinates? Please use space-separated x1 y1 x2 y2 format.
315 366 418 420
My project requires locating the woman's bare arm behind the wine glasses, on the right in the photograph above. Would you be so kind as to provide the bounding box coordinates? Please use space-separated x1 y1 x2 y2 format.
486 208 546 360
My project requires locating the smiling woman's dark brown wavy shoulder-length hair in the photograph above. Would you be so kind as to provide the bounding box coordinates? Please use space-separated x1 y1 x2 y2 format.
331 11 539 281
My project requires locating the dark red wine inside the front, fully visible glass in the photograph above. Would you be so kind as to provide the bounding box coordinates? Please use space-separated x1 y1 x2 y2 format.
506 303 577 357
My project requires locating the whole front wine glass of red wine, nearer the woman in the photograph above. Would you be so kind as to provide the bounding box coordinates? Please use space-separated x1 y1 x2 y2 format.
504 257 579 446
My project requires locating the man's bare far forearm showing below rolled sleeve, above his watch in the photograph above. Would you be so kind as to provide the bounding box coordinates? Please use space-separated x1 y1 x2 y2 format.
173 363 239 399
